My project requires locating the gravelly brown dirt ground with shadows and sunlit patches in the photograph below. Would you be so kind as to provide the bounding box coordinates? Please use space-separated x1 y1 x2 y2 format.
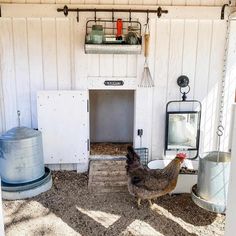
3 171 225 236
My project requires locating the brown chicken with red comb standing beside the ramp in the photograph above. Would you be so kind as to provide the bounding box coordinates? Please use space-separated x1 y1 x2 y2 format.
126 146 186 207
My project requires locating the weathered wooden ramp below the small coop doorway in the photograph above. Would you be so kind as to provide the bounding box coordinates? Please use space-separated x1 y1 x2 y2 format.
88 156 128 194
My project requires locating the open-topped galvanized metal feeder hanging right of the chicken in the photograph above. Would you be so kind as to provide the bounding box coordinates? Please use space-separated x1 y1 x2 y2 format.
192 151 231 213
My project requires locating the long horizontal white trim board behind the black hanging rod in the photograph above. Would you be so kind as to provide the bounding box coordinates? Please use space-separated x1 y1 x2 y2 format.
1 4 235 20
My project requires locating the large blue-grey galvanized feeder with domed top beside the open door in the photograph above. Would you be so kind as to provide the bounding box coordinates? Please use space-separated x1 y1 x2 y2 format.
0 112 52 200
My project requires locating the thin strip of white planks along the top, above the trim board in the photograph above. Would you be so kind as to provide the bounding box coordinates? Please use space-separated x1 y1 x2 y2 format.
1 0 232 6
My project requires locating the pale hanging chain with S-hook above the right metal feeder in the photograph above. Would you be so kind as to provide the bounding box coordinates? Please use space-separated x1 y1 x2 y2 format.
216 19 230 163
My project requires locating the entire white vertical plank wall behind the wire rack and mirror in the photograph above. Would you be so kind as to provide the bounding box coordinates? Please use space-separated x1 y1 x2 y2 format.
0 1 233 168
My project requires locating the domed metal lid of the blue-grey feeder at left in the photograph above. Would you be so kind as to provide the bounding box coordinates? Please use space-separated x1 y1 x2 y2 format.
0 127 41 141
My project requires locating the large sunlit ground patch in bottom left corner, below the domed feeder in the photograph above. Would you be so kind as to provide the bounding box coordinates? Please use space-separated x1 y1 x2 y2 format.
4 201 81 236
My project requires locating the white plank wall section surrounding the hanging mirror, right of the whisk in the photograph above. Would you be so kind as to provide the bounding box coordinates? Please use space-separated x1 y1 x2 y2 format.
152 20 229 158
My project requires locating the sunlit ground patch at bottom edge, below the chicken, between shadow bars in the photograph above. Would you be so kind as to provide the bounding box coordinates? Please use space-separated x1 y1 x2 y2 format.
121 220 163 236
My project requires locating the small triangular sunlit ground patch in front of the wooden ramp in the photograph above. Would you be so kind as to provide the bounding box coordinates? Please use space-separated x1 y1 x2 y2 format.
76 206 120 228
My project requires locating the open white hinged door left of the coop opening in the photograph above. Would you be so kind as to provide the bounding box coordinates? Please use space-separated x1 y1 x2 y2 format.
37 90 89 164
